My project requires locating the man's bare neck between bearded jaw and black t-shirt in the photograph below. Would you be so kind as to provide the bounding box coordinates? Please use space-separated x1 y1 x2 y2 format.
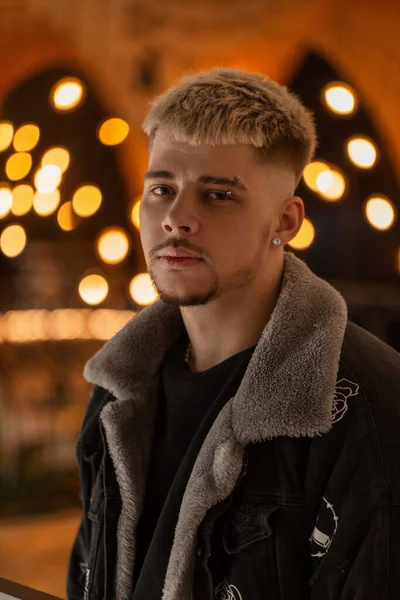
180 256 283 371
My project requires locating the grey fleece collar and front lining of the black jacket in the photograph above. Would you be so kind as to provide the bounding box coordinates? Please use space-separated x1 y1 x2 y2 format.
85 253 347 600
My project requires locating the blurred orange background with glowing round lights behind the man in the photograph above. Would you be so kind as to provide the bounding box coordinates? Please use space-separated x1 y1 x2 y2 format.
0 0 400 598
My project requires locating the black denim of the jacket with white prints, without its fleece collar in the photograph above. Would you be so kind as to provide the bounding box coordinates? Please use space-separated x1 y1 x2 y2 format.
68 324 400 600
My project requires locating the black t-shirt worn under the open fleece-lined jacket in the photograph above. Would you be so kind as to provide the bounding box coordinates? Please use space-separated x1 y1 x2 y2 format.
134 335 255 597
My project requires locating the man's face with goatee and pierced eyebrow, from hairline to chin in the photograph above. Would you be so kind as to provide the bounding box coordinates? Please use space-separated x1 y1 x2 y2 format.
140 131 292 306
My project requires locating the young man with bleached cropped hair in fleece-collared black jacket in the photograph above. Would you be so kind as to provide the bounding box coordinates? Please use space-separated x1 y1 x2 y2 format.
68 69 400 600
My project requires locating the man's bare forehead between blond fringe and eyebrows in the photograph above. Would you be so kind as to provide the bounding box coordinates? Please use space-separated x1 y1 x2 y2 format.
149 131 260 176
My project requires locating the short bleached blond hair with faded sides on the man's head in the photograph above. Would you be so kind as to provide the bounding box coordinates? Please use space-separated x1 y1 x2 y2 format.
142 68 316 178
